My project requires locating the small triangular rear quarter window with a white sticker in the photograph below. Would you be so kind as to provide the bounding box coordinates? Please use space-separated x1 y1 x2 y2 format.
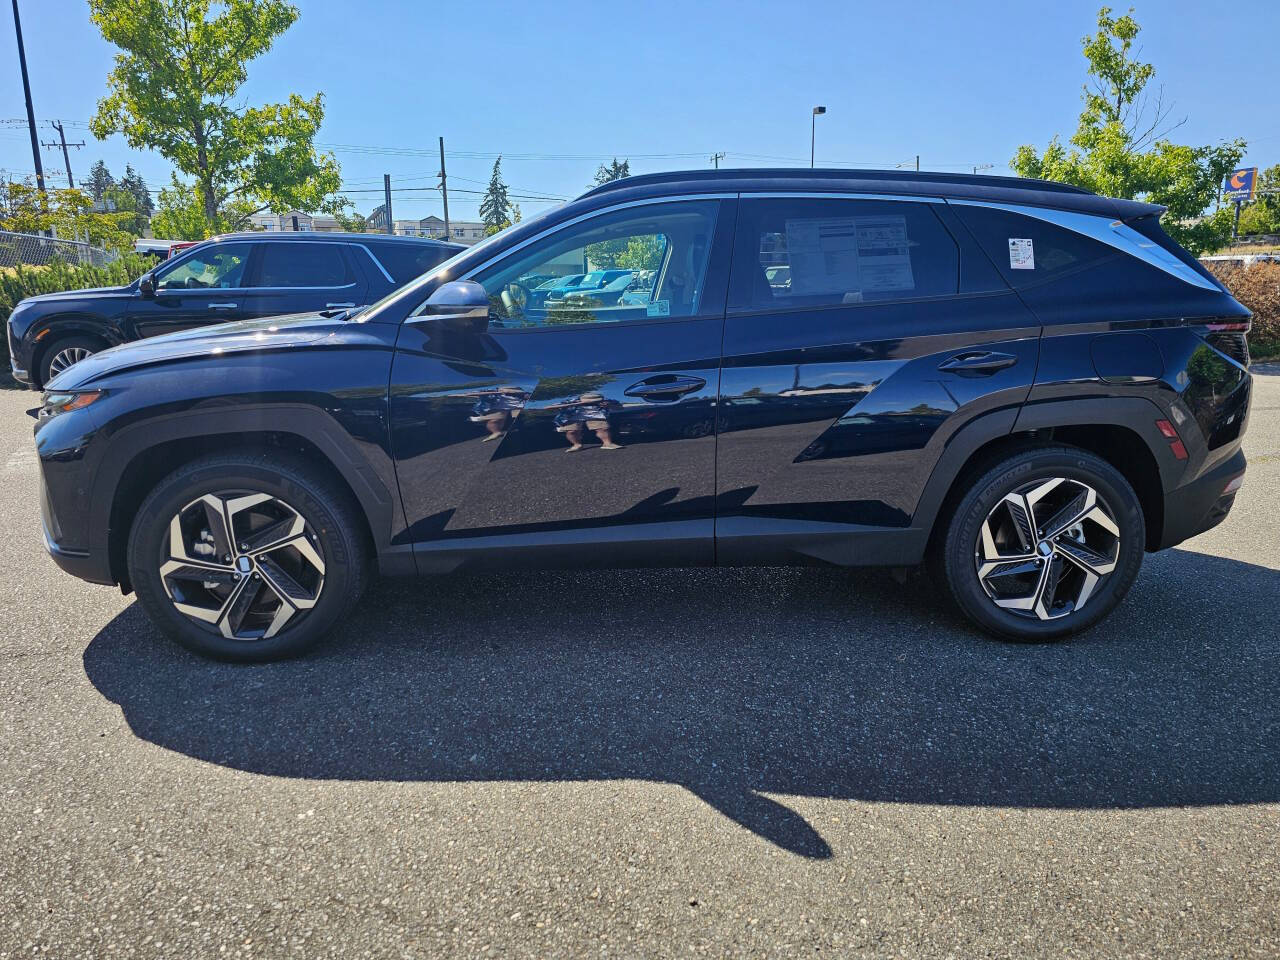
951 204 1116 288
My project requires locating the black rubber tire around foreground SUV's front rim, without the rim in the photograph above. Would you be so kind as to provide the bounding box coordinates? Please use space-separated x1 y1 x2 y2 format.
128 458 358 660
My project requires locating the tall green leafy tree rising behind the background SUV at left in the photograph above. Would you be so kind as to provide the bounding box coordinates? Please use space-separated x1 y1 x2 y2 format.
90 0 340 233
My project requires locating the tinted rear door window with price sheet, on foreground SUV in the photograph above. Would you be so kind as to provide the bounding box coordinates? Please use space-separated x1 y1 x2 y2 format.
730 197 960 310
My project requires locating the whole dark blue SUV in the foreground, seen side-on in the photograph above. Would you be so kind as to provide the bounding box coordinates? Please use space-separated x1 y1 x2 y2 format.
36 170 1251 659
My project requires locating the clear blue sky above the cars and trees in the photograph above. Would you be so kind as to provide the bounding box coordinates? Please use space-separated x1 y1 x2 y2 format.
0 0 1280 218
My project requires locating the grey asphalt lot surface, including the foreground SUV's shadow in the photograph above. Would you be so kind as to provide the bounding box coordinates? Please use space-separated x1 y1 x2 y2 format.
0 369 1280 957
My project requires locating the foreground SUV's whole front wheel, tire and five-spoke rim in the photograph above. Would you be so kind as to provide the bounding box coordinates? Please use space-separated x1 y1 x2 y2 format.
128 453 367 660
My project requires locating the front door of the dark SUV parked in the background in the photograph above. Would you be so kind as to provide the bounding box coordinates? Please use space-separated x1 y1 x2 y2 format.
124 242 253 339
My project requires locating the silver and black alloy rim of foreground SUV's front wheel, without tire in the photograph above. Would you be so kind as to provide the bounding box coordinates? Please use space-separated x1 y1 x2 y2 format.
160 490 325 640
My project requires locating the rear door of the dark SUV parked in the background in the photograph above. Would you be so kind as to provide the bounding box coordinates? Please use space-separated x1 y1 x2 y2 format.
242 239 366 317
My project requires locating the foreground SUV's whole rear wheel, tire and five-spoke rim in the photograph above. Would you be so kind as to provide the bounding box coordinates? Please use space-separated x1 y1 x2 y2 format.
936 447 1146 641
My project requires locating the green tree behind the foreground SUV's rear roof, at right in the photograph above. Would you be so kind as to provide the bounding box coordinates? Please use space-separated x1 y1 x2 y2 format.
1010 6 1244 255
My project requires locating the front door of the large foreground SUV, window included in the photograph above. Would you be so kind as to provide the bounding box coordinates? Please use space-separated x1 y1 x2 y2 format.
390 200 735 572
